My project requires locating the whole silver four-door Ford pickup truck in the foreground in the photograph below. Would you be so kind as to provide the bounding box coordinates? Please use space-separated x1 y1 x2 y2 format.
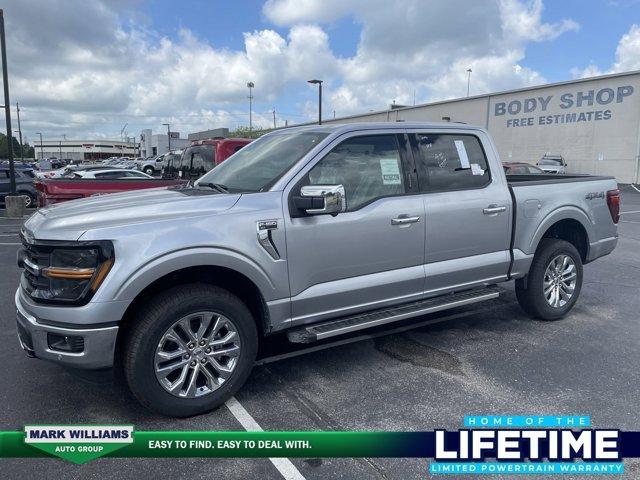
15 123 620 416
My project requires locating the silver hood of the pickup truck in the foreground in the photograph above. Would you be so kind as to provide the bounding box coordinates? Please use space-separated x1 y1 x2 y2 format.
24 188 240 240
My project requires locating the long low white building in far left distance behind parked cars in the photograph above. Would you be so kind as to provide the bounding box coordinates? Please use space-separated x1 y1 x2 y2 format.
33 139 140 160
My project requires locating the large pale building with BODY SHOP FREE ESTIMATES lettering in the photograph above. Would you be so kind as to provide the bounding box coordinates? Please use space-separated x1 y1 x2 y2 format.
314 71 640 183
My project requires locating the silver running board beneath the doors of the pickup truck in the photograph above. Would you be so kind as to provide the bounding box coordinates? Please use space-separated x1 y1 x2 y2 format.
287 287 500 343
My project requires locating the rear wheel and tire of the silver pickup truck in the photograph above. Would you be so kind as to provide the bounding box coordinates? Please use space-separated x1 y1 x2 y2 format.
516 238 582 320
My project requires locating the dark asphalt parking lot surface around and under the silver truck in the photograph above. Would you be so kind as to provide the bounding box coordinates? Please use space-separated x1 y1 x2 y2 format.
0 187 640 479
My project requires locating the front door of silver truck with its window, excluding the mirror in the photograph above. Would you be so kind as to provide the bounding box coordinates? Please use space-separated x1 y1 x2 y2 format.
285 133 424 325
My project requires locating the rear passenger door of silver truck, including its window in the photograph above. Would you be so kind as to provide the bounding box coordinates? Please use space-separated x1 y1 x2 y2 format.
410 131 511 296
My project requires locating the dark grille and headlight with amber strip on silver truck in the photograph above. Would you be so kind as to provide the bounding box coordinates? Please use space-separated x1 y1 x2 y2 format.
18 241 114 304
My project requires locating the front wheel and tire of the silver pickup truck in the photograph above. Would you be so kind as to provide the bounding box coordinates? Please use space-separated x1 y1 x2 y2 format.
123 283 258 417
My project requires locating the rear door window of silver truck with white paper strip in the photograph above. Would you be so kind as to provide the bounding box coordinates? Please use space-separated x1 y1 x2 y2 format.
412 133 491 192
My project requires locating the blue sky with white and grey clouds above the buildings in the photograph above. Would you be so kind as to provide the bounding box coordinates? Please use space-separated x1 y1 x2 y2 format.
3 0 640 141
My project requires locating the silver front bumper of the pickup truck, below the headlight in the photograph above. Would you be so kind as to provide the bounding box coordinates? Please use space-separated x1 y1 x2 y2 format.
15 291 118 369
